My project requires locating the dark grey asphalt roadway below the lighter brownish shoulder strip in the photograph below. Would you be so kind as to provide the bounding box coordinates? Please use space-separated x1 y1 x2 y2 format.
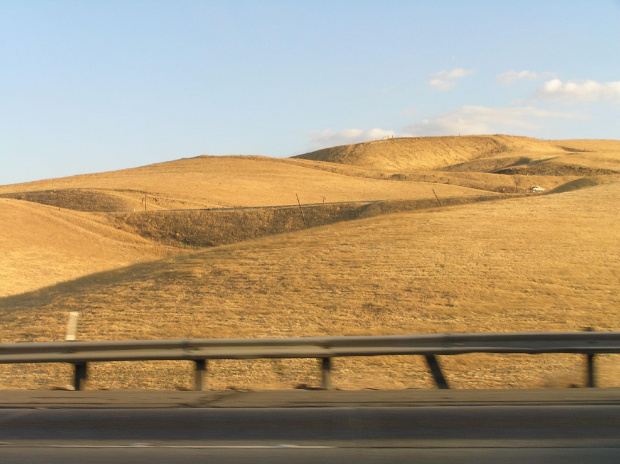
0 405 620 464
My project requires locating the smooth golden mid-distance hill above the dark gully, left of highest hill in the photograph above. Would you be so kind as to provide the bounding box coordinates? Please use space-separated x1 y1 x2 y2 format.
0 156 490 210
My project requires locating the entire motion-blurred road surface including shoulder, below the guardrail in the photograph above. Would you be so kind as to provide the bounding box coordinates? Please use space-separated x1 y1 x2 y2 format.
0 389 620 464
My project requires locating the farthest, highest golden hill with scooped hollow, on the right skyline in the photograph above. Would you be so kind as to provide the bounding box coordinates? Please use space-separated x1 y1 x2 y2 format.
297 135 620 176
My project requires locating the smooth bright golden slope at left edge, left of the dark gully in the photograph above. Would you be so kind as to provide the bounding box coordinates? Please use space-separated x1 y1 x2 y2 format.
0 198 169 297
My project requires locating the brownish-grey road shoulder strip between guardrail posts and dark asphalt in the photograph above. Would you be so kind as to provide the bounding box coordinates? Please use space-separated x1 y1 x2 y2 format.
0 388 620 409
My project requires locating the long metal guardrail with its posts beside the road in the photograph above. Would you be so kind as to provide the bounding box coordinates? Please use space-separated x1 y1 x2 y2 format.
0 332 620 390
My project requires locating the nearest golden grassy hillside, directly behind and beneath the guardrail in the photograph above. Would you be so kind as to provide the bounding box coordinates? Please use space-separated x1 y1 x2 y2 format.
0 184 620 388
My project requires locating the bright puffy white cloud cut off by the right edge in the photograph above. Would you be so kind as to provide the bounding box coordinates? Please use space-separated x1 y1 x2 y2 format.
534 79 620 102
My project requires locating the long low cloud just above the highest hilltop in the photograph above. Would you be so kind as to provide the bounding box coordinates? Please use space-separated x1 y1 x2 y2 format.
405 106 585 136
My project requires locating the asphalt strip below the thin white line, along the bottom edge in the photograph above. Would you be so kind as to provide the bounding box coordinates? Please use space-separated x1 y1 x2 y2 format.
0 447 619 464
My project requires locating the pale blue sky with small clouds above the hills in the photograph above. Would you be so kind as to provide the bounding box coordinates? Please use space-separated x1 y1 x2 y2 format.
0 0 620 185
